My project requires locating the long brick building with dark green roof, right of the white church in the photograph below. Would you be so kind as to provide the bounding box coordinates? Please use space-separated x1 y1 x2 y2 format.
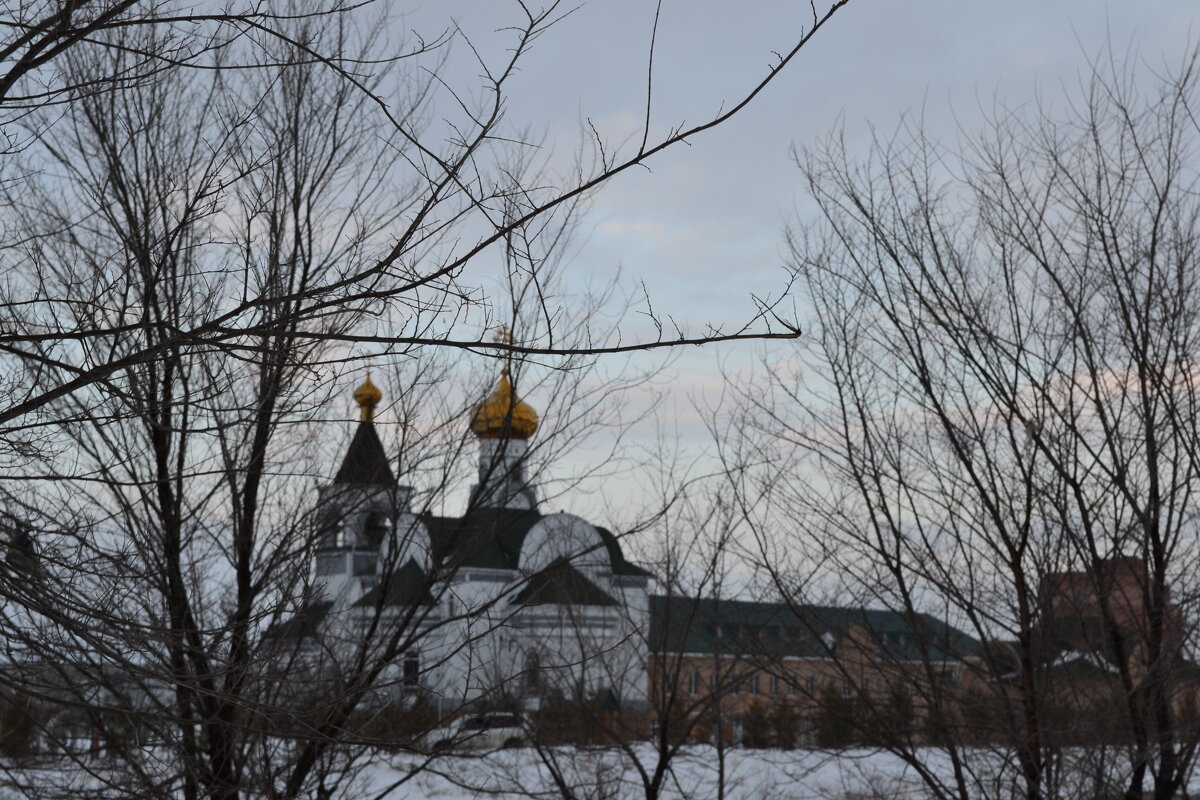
648 596 979 745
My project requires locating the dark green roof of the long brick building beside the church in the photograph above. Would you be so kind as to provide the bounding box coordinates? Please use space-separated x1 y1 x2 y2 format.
650 595 979 661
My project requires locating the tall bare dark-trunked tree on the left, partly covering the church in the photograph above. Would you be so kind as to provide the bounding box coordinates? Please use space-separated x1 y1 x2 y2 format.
0 0 864 798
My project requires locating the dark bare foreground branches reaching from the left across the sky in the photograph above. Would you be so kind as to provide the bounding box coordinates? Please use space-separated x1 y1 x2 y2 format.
0 0 847 462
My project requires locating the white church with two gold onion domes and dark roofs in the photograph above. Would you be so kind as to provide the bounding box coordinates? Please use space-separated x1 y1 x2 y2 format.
275 357 653 710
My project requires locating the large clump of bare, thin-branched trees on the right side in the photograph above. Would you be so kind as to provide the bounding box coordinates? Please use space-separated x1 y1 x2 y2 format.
725 52 1200 799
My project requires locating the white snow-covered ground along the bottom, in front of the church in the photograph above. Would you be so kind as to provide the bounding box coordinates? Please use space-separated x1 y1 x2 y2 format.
0 745 1200 800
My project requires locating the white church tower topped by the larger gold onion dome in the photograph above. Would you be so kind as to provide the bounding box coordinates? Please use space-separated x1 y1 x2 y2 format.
470 329 538 510
